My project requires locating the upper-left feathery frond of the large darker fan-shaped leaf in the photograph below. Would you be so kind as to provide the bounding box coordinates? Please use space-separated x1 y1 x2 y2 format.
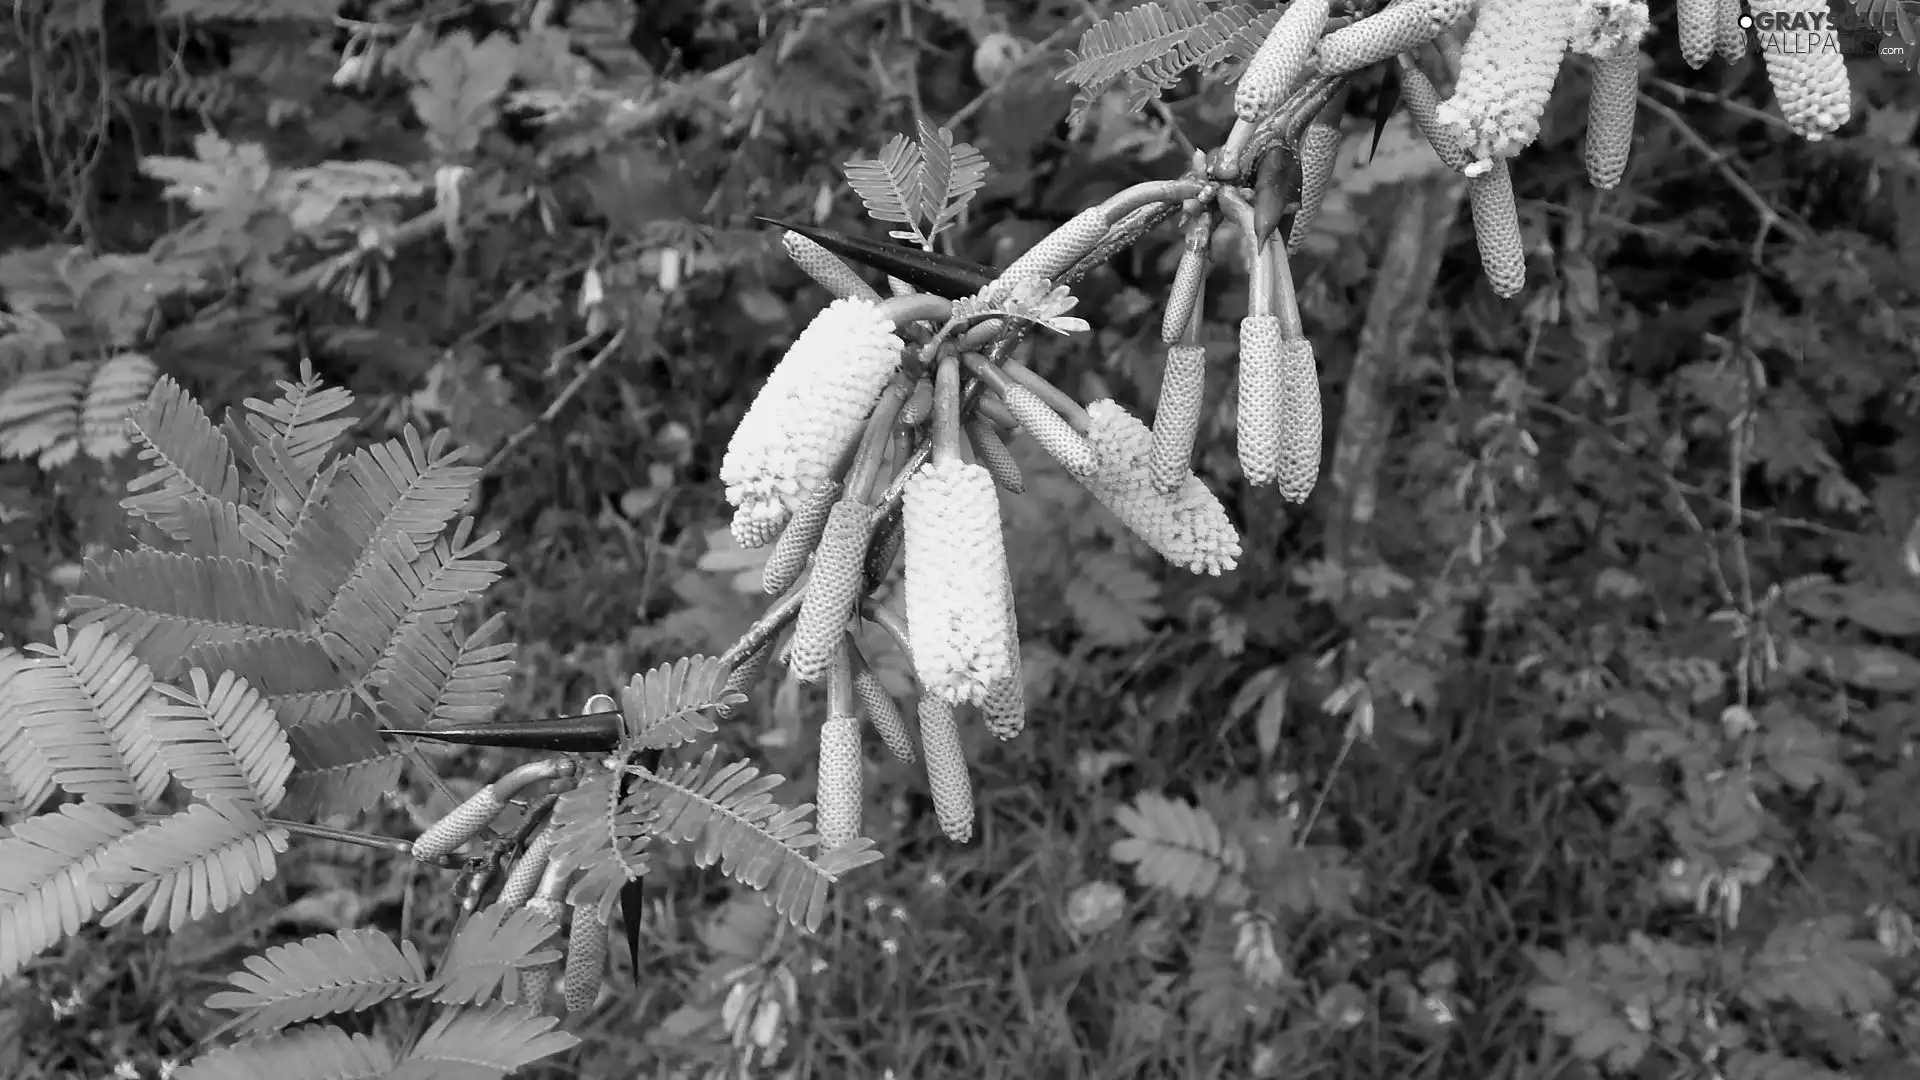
121 377 240 542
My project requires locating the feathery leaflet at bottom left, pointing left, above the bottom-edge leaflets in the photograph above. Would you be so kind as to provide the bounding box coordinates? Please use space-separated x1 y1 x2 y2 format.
207 928 428 1034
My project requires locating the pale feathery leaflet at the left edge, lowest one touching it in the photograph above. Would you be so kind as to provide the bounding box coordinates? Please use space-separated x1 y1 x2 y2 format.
0 803 134 980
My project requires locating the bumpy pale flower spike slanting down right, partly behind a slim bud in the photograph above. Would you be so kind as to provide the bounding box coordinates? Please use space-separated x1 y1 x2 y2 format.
1083 400 1240 575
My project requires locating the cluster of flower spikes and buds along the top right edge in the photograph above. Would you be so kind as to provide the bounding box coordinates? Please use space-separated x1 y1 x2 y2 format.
1215 0 1851 296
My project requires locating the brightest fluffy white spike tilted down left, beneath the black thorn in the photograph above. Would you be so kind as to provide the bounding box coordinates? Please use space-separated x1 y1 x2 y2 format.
720 300 902 521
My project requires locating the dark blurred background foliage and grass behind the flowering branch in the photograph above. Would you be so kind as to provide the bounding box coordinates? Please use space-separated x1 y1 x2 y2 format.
0 0 1920 1080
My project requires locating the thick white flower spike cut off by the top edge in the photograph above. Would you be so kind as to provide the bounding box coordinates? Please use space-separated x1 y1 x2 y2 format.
1438 0 1576 160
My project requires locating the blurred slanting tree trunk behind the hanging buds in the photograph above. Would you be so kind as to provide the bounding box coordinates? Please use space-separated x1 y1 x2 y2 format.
1327 171 1467 567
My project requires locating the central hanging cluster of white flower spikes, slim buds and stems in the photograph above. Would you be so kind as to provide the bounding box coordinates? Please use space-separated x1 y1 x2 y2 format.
720 143 1428 847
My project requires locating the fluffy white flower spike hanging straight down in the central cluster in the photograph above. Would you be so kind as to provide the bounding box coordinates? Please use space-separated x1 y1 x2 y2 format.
904 461 1006 705
